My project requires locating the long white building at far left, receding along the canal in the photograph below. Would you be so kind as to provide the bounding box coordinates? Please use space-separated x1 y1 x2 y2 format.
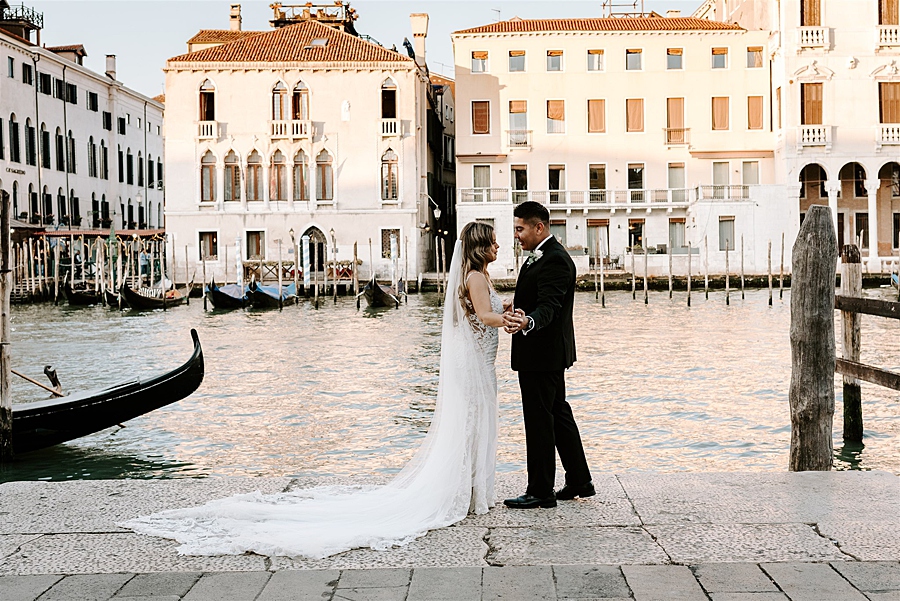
0 0 164 235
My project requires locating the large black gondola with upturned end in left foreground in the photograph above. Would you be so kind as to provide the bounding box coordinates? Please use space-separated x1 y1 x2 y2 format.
13 330 204 453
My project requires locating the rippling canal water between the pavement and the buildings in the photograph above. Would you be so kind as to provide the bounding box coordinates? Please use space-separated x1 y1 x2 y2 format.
0 290 900 481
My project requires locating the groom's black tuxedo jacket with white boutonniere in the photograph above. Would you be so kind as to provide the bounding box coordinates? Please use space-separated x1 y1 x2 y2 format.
512 238 575 371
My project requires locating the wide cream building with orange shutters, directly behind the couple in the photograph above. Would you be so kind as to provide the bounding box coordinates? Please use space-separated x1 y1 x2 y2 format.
452 12 799 275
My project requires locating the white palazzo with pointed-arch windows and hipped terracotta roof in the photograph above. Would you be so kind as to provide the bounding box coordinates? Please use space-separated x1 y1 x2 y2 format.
166 3 446 280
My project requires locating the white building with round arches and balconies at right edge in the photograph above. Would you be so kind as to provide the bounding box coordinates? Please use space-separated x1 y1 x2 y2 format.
707 0 900 272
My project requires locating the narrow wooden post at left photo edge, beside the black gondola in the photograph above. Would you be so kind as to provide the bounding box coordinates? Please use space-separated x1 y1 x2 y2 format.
0 190 13 463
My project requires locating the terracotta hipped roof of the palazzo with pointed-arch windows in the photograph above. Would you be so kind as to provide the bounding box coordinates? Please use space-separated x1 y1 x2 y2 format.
169 21 413 63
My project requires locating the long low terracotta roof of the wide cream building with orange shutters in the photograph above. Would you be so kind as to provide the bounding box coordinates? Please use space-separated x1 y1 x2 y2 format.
453 17 743 34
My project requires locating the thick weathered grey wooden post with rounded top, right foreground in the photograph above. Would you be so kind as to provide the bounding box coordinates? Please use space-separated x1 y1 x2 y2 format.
789 205 837 472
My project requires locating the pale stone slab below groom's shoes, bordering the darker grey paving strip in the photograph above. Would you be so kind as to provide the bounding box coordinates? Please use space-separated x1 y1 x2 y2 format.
487 526 668 566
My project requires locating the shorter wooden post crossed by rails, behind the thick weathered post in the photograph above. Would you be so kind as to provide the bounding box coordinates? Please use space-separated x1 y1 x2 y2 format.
841 244 863 442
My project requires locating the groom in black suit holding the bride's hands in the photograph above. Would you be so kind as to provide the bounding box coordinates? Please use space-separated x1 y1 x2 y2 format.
504 201 594 509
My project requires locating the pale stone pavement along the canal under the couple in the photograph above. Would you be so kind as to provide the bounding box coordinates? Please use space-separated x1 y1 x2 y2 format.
0 472 900 601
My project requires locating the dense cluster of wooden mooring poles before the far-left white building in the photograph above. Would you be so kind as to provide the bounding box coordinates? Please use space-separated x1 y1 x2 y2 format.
11 233 174 302
